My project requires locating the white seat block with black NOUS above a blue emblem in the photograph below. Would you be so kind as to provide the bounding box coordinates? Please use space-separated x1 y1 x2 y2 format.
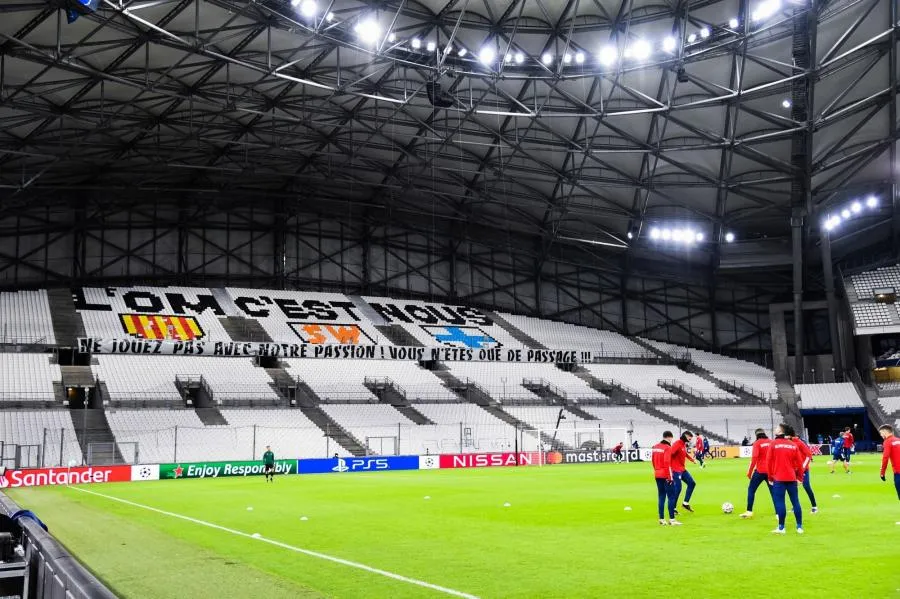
363 297 524 348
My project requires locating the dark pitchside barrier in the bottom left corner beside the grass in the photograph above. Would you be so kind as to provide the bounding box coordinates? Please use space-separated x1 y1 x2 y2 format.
0 493 116 599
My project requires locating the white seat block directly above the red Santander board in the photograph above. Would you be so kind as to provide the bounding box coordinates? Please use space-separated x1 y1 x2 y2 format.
0 410 82 467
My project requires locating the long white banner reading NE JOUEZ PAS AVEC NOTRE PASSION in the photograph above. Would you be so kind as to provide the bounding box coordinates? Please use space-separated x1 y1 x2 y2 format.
78 337 600 364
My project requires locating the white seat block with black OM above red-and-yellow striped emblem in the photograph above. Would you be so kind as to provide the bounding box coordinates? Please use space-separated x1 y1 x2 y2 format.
79 287 231 341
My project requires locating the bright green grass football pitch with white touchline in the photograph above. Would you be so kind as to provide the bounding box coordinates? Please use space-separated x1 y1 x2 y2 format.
10 455 900 599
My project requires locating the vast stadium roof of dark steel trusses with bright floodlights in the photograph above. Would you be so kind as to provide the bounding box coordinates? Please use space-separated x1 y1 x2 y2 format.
0 0 900 276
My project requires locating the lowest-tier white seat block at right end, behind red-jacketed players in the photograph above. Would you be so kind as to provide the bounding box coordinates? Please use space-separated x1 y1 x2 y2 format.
659 406 781 443
